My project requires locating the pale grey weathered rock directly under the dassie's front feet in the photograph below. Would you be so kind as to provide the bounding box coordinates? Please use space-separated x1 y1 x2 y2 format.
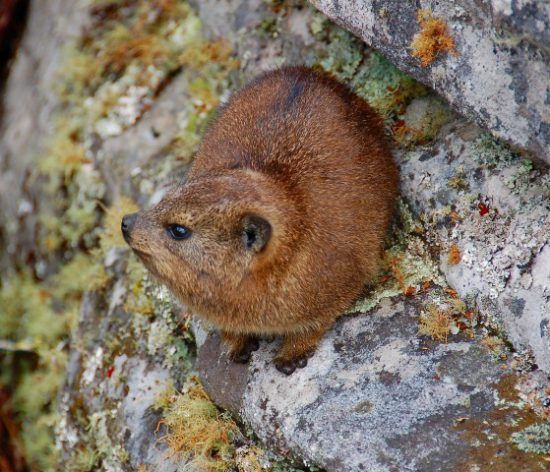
198 296 545 472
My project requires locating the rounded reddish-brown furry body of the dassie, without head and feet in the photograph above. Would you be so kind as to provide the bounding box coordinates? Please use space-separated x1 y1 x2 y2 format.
189 67 398 334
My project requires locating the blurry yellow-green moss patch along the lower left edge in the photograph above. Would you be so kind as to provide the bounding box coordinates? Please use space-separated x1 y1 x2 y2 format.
0 273 77 470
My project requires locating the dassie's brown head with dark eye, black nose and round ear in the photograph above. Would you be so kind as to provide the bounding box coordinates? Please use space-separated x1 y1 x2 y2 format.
121 171 294 314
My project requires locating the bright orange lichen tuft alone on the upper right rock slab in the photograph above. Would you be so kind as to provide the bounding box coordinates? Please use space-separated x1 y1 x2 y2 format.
410 10 458 67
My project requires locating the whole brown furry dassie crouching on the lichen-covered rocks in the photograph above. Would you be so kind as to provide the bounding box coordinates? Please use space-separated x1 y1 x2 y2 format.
122 67 398 374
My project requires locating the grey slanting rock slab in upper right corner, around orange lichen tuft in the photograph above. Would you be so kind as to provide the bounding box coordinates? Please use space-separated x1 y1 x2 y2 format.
311 0 550 162
